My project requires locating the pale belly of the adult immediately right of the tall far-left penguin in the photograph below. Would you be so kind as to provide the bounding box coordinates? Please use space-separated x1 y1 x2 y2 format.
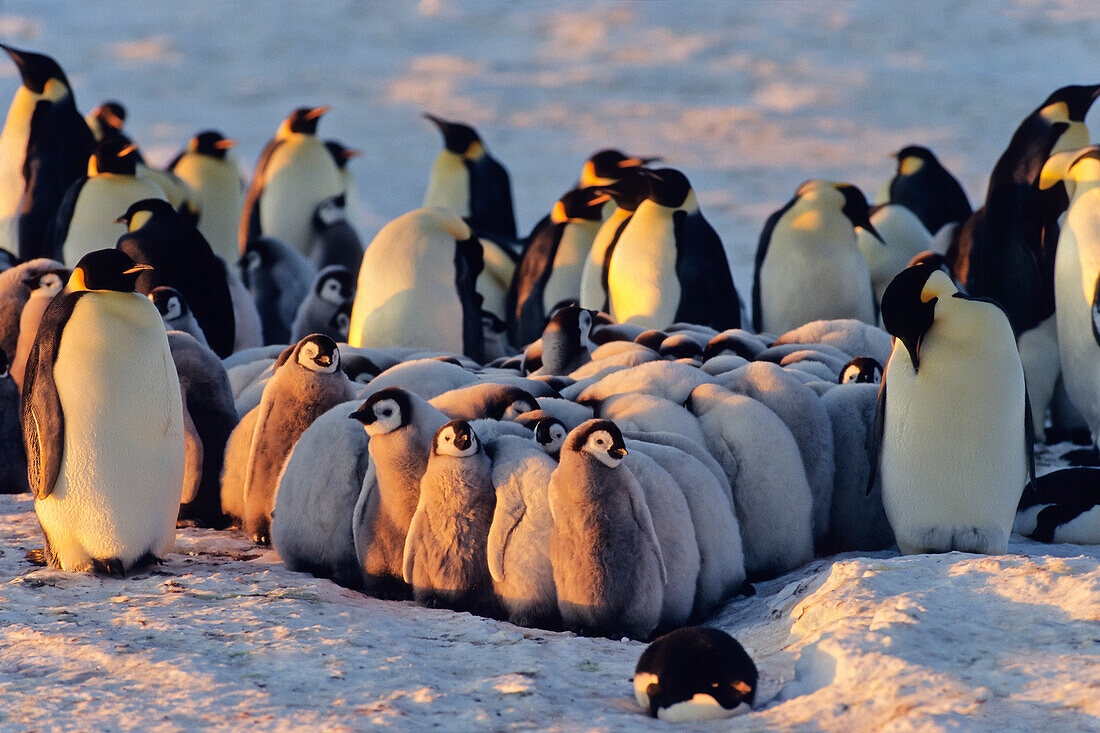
62 174 167 267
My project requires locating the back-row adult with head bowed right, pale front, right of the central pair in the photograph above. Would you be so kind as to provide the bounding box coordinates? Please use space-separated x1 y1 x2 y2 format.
752 179 878 333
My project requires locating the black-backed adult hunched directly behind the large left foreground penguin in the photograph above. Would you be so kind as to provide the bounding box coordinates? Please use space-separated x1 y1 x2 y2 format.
116 198 237 359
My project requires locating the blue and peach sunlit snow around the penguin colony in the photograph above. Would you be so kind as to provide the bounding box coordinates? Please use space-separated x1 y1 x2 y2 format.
0 0 1100 732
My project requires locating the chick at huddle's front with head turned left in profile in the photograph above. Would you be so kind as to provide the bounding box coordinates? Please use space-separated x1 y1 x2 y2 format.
349 387 448 595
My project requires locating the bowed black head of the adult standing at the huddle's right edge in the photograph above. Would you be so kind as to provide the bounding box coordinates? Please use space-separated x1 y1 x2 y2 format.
882 264 958 372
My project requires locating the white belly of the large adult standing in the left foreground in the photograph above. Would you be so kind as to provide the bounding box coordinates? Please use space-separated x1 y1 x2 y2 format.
35 293 184 569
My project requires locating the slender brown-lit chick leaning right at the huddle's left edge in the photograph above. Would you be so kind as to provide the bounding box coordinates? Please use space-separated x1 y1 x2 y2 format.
244 333 355 545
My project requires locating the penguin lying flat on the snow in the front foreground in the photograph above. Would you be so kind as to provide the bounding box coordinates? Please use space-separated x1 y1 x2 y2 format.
634 626 759 722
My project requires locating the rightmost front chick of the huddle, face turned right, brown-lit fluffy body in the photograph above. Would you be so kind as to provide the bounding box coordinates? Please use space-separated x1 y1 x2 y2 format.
548 419 668 638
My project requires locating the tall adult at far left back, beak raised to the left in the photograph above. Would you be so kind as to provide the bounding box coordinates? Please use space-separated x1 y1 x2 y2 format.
0 44 95 260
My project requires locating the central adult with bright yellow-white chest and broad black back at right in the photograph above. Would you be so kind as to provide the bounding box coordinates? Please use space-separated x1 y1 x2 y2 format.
607 168 741 331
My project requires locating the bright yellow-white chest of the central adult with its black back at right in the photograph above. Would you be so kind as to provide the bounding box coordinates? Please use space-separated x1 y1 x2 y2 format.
607 200 680 328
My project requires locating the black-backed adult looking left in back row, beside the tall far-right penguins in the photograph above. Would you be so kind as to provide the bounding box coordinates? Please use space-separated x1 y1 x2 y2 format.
887 145 972 234
